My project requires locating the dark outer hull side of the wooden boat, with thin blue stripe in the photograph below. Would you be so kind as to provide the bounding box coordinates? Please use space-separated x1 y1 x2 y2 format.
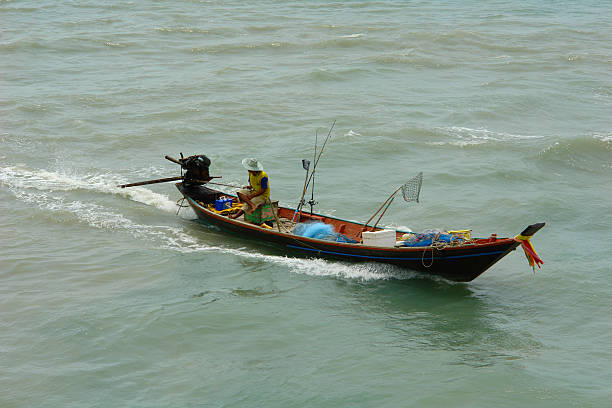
177 183 532 282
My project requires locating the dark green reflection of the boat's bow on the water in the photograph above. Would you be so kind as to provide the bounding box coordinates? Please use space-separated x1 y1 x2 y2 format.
338 276 542 367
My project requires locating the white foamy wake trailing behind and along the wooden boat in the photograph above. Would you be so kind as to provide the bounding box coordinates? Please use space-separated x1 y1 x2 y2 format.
0 166 422 281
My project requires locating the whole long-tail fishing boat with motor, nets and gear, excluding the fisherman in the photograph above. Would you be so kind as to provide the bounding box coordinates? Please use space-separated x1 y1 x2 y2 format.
121 151 545 282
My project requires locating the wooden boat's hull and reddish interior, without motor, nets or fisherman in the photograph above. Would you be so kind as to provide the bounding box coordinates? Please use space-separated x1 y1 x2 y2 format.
176 183 544 282
